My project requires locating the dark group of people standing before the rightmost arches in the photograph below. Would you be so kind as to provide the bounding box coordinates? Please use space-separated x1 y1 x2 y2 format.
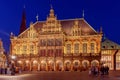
89 66 109 76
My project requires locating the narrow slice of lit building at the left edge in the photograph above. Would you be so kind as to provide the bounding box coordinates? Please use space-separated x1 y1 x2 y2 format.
0 39 6 68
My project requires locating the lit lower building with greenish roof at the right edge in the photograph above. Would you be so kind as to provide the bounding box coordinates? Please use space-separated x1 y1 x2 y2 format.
101 38 120 70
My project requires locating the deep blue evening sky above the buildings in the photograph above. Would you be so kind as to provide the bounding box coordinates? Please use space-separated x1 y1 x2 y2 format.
0 0 120 51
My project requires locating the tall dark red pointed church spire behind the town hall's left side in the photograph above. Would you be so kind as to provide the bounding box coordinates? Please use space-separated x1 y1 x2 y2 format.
19 5 26 34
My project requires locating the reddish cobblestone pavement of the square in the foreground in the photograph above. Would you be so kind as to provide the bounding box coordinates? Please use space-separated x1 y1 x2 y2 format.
0 71 120 80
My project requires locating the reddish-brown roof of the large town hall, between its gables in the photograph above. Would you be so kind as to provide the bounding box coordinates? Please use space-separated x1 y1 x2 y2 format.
34 18 97 35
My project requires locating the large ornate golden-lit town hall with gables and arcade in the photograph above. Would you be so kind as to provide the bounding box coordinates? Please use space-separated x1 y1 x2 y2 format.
10 8 102 71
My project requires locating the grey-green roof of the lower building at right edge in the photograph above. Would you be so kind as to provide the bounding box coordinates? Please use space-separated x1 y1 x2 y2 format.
101 38 120 49
